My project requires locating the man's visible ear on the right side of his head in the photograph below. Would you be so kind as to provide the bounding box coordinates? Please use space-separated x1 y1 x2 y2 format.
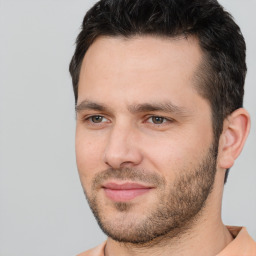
218 108 251 169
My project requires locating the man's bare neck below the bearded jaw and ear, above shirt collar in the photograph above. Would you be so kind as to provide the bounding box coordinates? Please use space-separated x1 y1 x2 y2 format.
105 173 233 256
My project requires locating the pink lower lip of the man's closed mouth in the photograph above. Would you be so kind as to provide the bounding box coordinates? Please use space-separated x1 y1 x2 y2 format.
104 188 150 202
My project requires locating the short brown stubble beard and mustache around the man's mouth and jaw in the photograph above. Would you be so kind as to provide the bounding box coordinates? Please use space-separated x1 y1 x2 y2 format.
85 145 217 245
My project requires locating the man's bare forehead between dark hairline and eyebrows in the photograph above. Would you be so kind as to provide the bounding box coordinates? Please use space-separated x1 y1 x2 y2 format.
78 36 202 106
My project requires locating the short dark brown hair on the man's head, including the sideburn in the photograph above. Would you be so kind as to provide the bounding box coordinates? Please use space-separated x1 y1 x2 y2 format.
70 0 246 144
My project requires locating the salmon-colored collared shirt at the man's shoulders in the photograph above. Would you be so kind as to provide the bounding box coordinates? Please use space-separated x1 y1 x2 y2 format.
77 226 256 256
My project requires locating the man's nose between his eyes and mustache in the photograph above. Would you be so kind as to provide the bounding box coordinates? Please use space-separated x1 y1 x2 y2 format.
104 124 143 169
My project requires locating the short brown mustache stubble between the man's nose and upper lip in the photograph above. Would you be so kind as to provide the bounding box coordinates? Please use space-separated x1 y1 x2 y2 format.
92 168 166 189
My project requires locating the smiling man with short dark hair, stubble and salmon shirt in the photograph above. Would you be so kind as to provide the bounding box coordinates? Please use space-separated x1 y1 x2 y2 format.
70 0 256 256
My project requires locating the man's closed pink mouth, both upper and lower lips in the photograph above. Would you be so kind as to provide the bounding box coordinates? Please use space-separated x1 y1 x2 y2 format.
102 182 153 202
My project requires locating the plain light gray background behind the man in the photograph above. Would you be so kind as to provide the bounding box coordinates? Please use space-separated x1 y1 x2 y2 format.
0 0 256 256
